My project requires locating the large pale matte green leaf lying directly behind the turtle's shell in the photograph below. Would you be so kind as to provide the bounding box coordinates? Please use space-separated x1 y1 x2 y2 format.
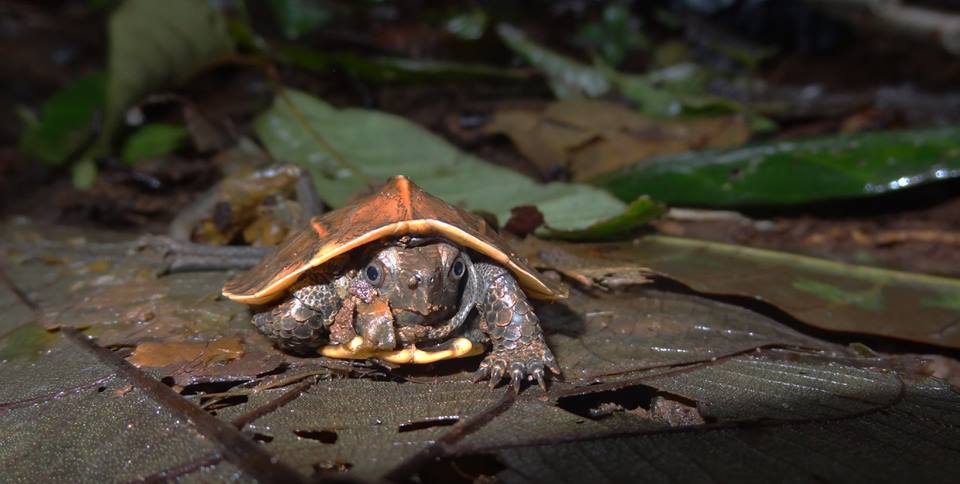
255 90 646 234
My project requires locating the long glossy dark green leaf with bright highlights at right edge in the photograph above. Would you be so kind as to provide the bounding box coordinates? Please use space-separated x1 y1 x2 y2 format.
592 127 960 206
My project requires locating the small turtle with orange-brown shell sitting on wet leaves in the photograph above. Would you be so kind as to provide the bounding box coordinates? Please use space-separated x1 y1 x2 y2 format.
223 175 567 389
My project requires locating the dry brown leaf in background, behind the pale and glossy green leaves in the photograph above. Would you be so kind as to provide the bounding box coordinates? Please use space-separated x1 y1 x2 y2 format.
484 100 750 180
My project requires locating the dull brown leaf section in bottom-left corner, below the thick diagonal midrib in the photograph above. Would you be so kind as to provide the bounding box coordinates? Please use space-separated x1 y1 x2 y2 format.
0 336 251 481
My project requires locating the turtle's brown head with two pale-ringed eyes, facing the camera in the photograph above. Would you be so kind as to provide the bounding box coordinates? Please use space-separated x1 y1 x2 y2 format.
359 241 467 326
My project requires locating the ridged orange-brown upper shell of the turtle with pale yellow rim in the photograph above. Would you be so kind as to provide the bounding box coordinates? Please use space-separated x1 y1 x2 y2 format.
223 176 566 304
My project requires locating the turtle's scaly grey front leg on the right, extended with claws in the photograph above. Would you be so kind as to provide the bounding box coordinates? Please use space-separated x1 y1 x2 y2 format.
475 263 560 391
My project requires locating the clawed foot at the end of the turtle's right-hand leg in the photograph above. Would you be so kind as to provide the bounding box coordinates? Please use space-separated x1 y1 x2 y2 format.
474 340 560 393
